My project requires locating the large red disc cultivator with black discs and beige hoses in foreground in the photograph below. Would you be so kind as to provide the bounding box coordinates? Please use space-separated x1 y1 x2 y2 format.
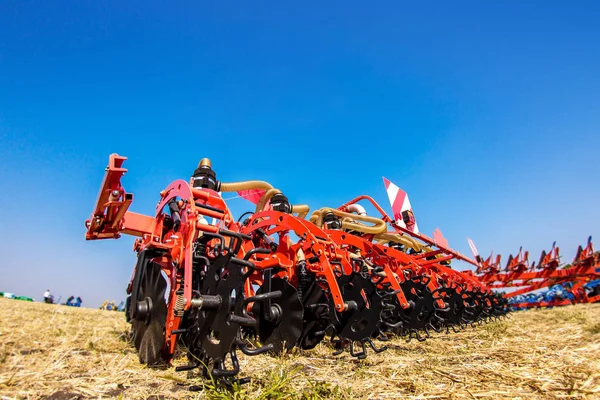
86 154 508 380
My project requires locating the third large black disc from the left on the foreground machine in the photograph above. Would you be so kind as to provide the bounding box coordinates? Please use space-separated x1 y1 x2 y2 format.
252 278 304 353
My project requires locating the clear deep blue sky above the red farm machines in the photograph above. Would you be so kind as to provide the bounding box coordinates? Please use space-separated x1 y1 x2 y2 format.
0 0 600 307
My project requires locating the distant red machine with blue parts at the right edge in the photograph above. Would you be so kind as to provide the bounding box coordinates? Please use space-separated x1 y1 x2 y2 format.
469 236 600 310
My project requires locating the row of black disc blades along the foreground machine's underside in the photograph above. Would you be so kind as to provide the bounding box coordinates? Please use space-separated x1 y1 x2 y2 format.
128 253 507 373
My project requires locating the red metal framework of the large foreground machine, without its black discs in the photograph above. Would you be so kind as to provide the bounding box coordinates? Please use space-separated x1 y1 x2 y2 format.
85 154 510 372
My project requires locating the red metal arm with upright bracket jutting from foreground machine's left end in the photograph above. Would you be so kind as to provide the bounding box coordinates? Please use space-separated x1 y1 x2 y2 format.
85 153 154 240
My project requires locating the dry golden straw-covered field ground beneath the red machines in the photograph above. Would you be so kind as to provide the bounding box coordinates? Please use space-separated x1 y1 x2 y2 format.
0 298 600 400
